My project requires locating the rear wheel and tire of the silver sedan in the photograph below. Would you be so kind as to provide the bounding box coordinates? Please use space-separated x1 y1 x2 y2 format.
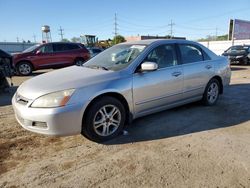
202 78 220 106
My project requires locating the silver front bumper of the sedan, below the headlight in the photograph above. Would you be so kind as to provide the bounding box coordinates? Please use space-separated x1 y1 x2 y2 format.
12 96 83 136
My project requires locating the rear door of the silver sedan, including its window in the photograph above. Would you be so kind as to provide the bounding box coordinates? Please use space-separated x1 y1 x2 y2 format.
178 44 214 99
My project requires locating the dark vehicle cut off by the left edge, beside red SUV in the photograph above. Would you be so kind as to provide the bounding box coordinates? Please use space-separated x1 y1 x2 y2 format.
0 49 14 91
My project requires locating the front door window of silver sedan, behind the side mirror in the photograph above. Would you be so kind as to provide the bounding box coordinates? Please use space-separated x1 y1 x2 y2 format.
144 45 177 69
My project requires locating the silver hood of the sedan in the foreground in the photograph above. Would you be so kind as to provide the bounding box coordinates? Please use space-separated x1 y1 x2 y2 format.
17 66 120 100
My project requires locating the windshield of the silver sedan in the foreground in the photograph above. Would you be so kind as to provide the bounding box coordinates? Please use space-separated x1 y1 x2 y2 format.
83 44 146 71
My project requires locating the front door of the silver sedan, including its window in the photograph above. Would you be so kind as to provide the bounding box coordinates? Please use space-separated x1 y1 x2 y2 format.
133 44 183 116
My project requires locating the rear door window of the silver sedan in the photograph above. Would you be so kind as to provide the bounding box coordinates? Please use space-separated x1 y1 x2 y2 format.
179 44 204 64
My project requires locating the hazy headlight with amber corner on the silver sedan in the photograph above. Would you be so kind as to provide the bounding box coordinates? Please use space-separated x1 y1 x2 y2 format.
31 89 75 108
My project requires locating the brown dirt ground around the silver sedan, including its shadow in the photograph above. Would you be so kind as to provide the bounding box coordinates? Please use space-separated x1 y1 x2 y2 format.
0 66 250 188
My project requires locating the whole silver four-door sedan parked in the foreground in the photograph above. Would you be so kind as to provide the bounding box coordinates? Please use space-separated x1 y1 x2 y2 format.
12 39 231 142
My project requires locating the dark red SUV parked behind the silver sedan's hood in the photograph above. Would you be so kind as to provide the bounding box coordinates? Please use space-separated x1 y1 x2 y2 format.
13 42 90 76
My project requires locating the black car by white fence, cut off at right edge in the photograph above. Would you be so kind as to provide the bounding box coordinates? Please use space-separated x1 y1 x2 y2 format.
222 45 250 65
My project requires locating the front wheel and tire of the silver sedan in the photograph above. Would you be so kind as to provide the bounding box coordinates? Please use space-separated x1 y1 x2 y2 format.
82 96 126 143
